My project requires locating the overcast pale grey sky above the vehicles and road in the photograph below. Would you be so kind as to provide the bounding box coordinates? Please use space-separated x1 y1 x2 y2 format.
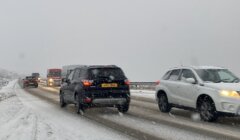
0 0 240 81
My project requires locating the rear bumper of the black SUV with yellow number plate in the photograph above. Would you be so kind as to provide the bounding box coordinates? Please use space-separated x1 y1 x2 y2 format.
92 98 128 105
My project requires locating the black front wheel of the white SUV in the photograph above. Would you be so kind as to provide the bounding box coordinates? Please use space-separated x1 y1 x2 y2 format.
198 96 218 122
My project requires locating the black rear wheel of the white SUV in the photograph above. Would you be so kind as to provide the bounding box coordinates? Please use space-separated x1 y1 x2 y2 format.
158 94 171 113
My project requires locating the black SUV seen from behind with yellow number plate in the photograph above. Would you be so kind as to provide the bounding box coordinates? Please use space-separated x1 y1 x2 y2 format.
59 66 130 113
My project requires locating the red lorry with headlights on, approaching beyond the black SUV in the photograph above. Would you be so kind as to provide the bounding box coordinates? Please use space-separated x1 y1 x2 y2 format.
47 69 62 86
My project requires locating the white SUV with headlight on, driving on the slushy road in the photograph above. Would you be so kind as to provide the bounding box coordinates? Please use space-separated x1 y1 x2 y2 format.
156 66 240 122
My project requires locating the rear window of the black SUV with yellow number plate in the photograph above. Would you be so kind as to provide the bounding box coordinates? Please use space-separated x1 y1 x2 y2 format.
89 68 126 80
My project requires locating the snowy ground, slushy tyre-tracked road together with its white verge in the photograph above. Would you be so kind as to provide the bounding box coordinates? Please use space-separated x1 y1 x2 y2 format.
0 81 240 140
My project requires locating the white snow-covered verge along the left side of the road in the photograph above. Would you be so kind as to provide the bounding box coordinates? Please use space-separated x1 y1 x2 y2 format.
0 80 129 140
